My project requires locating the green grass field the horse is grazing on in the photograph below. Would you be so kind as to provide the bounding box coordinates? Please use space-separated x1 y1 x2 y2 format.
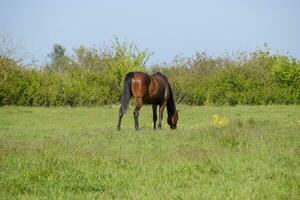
0 105 300 199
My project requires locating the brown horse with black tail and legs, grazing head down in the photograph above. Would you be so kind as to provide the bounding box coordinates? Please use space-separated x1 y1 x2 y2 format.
117 72 178 130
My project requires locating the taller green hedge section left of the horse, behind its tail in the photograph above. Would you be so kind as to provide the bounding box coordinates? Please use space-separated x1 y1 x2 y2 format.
0 40 150 106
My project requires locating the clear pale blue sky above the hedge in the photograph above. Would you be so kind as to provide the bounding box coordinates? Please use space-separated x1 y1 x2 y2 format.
0 0 300 65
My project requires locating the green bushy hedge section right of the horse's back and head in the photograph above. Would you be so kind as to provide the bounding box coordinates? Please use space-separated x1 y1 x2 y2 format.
153 48 300 105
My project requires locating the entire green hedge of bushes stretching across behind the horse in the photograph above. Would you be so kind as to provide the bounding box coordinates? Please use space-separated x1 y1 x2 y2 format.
0 39 300 106
